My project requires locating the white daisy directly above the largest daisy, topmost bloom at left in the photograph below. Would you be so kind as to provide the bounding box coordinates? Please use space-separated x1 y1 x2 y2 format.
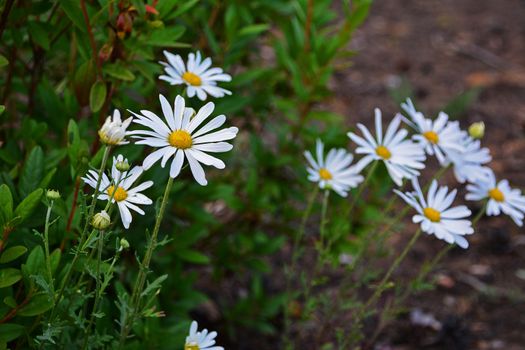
159 51 232 101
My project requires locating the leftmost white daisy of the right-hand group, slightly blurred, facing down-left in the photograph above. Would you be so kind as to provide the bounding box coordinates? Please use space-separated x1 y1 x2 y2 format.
304 140 363 197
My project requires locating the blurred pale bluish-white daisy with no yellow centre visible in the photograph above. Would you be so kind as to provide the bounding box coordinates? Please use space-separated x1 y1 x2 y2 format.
447 136 492 183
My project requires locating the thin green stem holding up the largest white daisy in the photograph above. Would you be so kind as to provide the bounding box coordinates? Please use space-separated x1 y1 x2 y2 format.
119 176 173 348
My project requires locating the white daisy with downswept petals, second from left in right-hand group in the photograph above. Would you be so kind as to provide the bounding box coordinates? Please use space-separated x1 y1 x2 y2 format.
348 108 425 186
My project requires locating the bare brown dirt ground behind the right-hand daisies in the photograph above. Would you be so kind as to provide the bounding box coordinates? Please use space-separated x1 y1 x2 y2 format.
331 0 525 350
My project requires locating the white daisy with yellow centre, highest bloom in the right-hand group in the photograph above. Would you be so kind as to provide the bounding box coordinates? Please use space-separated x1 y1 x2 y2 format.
401 98 466 166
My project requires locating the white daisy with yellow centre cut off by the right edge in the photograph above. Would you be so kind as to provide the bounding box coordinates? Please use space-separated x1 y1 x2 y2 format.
465 172 525 226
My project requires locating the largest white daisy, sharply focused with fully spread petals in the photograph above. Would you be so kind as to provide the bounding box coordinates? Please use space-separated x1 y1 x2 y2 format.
130 95 239 186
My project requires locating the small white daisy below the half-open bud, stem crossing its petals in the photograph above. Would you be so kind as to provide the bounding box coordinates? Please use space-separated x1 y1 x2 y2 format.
82 154 153 228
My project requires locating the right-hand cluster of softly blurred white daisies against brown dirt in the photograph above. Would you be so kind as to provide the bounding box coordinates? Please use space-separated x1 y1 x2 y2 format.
305 99 525 248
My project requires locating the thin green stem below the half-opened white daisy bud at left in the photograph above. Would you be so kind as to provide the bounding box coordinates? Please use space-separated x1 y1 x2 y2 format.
49 146 111 323
